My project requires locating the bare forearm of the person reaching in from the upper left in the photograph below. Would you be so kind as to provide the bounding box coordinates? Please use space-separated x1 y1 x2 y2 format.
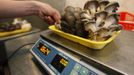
0 0 38 18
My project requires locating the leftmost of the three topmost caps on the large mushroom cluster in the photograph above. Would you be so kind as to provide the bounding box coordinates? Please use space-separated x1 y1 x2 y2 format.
84 0 99 16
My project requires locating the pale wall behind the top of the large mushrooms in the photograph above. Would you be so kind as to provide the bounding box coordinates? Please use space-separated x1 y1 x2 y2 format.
66 0 134 14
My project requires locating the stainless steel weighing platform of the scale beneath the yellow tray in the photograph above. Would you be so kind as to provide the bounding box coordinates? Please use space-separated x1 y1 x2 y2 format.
42 30 134 75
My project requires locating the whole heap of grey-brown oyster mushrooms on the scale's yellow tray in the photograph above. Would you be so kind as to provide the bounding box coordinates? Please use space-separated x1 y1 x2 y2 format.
58 0 122 41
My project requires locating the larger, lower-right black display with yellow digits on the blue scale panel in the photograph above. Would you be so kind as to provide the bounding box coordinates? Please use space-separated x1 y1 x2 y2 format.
51 54 68 73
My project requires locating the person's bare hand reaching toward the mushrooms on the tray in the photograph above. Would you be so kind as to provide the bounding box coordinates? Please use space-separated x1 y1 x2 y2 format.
36 2 61 24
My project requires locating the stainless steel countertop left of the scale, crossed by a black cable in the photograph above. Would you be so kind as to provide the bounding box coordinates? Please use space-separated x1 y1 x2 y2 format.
5 32 48 75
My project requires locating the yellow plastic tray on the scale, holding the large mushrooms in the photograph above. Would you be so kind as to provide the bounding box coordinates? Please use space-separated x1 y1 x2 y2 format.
49 25 121 49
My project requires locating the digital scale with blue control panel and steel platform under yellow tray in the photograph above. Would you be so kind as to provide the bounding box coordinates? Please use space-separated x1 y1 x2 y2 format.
31 30 134 75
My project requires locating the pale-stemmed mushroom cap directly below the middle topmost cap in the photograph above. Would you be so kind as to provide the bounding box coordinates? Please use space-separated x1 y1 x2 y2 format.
95 11 108 27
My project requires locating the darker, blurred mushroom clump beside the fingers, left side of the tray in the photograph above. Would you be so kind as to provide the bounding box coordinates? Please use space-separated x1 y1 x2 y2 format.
61 6 82 34
